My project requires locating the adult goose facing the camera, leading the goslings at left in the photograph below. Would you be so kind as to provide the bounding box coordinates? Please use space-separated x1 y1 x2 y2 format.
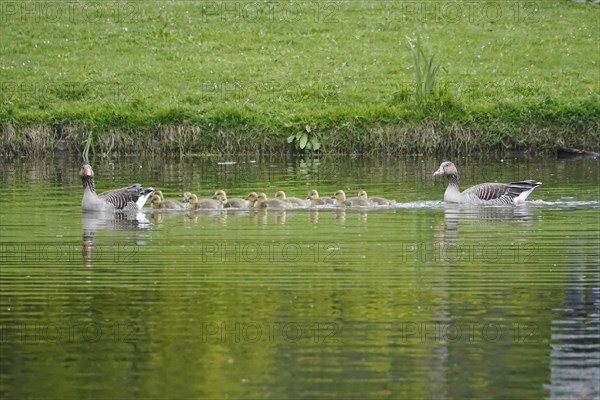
79 164 154 211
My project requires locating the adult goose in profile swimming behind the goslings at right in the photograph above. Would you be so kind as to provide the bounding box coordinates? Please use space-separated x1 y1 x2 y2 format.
433 161 542 205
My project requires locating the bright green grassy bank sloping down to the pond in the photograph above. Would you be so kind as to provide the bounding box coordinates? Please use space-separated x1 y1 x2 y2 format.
0 0 600 153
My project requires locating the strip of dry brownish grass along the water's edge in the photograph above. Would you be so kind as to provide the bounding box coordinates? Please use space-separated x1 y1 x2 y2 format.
0 120 600 157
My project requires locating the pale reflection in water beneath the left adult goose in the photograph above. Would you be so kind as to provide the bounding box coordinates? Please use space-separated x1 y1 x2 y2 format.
81 211 151 267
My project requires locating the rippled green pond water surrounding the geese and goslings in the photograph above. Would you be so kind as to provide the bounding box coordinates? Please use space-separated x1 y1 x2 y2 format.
0 157 600 399
